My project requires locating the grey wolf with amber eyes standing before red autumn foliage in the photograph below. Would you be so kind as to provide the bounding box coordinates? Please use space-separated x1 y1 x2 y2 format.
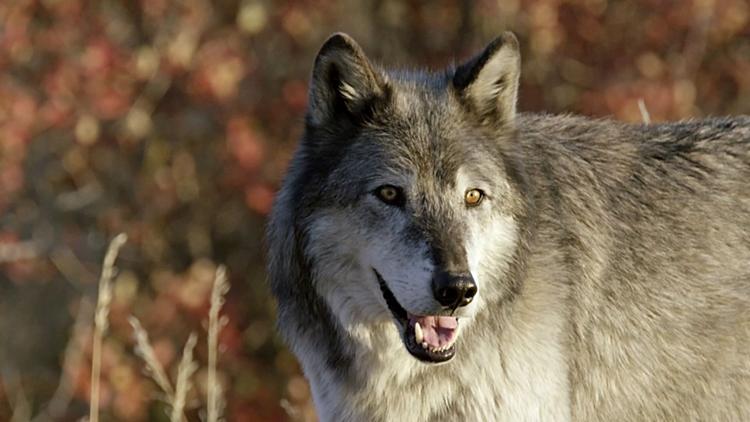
267 33 750 421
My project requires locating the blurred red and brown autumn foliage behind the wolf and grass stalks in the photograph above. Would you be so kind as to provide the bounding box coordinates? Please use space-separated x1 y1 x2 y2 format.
0 0 750 421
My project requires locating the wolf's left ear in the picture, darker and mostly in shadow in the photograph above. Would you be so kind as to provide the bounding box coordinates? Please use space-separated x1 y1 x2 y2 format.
308 33 386 125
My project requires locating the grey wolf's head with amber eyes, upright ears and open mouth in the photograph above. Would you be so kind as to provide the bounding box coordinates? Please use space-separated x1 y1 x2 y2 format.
269 33 525 362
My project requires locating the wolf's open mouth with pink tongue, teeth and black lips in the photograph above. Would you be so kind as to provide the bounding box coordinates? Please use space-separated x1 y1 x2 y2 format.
373 269 458 363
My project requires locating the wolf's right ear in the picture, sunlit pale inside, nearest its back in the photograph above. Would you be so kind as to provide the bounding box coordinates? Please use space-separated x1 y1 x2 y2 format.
453 32 521 123
